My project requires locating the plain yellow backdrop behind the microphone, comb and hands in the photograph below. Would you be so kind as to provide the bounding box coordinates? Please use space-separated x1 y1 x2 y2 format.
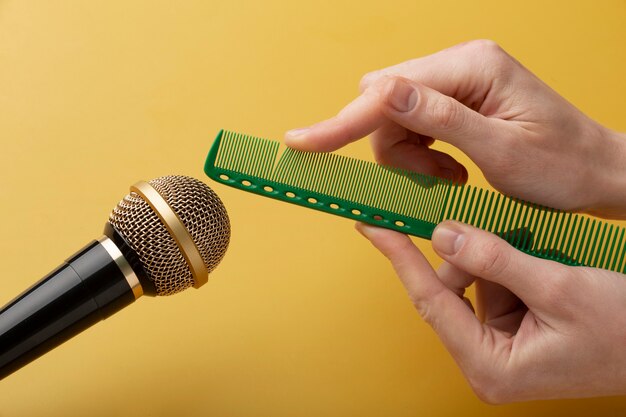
0 0 626 417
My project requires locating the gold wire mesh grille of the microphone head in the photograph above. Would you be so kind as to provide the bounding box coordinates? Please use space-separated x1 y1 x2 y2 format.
109 175 230 295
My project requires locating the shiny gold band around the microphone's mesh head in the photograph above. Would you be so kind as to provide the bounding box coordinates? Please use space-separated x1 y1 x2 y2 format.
130 181 209 288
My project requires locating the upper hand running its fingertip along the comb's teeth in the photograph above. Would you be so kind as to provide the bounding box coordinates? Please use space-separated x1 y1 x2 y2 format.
286 41 626 218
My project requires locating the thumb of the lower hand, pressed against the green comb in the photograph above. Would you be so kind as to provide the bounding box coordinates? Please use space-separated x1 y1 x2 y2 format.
432 221 566 306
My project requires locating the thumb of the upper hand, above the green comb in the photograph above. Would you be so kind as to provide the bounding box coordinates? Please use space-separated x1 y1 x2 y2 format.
369 77 508 162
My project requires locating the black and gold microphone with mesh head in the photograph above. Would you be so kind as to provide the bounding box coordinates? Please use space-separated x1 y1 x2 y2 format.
0 176 230 379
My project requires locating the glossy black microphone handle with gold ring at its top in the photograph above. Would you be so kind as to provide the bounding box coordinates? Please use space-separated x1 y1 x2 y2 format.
0 226 143 379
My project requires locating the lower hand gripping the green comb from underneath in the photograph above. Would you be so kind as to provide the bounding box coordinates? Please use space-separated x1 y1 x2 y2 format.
357 222 626 403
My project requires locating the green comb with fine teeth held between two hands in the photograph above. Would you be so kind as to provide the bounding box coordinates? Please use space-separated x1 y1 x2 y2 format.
204 131 626 273
